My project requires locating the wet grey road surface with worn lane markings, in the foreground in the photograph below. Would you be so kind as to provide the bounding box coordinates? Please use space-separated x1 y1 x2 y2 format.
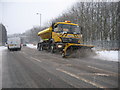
2 47 119 88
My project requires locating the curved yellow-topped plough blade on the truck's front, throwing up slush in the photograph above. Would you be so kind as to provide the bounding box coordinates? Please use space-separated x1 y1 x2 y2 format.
62 44 95 57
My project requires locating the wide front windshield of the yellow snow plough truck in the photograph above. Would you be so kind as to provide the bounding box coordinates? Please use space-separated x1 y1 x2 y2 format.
54 24 80 34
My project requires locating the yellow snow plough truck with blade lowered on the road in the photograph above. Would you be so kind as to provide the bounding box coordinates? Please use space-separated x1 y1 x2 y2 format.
37 21 94 57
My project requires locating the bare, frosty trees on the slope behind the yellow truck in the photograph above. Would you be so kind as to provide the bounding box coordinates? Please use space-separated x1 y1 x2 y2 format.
22 2 119 48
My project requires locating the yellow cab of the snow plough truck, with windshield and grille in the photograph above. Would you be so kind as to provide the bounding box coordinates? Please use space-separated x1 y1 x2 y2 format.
52 22 82 43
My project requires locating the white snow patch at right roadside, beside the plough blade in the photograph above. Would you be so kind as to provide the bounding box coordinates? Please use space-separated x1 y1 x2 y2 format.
94 51 118 62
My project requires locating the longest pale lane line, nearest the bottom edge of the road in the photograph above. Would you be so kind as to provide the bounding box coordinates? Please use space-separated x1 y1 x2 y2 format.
56 68 106 88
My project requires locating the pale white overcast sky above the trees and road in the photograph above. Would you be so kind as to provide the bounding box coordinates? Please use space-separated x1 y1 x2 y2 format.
0 0 78 34
